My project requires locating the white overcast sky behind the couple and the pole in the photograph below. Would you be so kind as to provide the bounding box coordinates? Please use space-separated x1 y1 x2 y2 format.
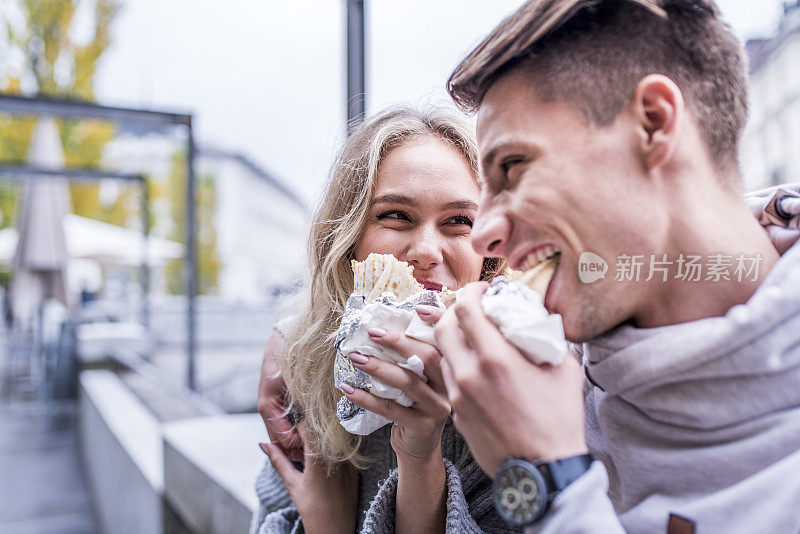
92 0 782 205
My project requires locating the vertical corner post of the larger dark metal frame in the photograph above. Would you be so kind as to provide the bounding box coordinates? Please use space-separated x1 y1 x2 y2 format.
184 118 197 391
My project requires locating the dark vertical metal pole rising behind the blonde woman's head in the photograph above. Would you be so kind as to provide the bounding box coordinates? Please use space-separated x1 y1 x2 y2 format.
346 0 367 133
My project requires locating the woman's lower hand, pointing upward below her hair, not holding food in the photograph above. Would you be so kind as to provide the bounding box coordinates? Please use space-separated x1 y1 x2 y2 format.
261 423 358 534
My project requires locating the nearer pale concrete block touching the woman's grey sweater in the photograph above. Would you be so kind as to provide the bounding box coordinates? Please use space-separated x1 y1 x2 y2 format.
163 414 266 534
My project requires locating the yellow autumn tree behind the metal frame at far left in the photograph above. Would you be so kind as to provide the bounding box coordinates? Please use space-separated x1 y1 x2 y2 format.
0 0 133 228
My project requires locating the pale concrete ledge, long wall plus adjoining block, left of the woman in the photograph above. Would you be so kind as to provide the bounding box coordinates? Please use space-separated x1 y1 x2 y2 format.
79 370 267 534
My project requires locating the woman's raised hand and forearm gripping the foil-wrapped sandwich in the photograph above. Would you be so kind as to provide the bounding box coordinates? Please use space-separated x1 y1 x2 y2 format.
342 328 450 534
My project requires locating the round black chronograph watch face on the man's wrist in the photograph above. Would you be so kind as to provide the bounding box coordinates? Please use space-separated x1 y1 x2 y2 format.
494 460 547 527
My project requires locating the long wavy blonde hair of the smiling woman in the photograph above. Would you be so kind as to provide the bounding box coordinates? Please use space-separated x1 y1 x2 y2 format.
281 106 505 468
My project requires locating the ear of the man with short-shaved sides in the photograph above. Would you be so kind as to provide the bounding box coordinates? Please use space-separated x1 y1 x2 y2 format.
631 74 685 169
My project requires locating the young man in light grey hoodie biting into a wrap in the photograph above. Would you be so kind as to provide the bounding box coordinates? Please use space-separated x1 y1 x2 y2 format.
432 0 800 533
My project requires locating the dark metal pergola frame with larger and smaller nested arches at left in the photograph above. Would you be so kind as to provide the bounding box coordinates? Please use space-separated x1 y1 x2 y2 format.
0 94 197 390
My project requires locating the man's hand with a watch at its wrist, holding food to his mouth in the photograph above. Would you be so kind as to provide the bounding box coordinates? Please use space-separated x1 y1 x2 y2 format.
418 283 587 477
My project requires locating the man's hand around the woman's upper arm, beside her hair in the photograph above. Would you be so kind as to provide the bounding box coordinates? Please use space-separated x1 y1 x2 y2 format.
258 333 303 462
